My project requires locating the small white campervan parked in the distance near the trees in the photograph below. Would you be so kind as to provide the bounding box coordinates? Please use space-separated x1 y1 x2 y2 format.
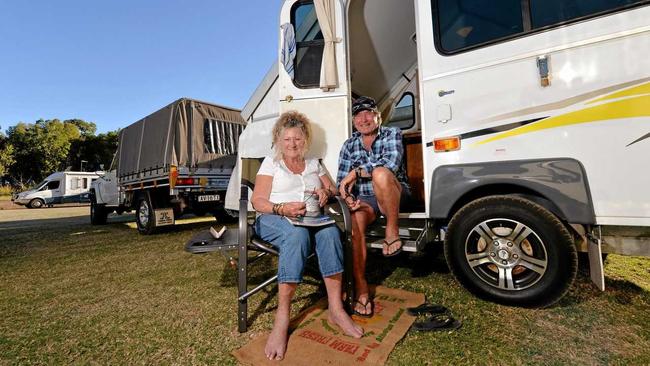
11 172 103 208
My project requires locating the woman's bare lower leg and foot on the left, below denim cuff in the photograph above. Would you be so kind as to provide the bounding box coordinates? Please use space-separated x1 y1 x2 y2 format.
264 283 298 360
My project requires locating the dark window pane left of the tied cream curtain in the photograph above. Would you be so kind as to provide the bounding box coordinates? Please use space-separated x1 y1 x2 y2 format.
291 1 325 88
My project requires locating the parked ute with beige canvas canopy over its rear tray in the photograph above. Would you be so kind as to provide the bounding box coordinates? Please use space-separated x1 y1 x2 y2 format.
90 98 245 234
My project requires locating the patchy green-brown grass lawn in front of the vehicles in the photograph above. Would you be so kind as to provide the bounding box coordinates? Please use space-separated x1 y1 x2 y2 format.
0 208 650 365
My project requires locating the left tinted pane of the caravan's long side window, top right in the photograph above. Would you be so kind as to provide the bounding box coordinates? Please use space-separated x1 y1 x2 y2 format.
437 0 524 52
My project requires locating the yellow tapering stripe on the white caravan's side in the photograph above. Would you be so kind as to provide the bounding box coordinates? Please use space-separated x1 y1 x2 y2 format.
473 95 650 146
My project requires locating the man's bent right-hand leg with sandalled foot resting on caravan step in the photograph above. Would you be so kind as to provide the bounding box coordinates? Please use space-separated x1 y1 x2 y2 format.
372 167 402 255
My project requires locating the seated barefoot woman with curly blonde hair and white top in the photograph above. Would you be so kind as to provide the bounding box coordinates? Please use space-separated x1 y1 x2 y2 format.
251 111 363 360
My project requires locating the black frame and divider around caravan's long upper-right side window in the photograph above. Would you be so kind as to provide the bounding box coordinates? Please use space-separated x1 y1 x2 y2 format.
431 0 650 56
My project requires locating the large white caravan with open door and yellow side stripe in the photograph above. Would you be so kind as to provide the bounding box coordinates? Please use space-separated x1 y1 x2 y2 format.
227 0 650 306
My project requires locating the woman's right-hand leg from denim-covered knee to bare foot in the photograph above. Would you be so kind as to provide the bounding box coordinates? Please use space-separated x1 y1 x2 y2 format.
314 225 363 338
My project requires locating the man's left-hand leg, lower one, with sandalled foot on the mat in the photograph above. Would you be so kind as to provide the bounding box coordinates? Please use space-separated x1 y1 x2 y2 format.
352 203 375 314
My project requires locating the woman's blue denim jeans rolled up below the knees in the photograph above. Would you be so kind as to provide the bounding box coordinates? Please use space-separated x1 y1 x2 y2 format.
255 214 343 283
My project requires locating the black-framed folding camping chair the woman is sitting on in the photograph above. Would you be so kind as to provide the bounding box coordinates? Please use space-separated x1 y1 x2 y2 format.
186 158 354 333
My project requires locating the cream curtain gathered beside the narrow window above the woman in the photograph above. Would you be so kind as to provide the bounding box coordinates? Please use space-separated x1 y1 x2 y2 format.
314 0 341 91
